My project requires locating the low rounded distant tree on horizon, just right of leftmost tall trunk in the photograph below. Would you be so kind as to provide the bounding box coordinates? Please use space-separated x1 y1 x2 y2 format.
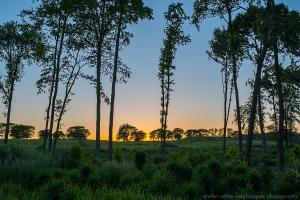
9 124 35 139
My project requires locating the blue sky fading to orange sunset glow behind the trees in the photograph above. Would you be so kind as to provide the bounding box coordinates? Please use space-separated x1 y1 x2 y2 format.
0 0 300 140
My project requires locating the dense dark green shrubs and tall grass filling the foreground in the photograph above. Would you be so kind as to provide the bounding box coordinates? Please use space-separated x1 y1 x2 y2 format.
0 142 300 200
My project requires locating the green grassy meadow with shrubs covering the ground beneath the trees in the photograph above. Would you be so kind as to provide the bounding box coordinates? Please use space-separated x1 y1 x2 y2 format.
0 137 300 200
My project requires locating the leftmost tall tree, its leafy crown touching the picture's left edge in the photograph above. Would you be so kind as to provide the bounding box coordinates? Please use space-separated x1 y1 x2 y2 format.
0 21 39 144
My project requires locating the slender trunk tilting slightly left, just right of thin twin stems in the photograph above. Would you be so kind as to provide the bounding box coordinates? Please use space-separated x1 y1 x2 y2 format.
226 5 243 152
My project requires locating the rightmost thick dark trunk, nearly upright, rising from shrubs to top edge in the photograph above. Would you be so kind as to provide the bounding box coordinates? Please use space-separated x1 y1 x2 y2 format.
273 0 284 171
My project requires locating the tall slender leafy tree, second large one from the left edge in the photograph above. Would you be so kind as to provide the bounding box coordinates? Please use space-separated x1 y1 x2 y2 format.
21 0 80 153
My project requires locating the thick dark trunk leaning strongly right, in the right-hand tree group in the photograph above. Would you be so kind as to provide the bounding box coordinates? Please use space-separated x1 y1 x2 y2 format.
246 0 271 166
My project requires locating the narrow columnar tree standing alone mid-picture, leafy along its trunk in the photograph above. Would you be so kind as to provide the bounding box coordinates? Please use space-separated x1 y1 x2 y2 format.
158 3 191 155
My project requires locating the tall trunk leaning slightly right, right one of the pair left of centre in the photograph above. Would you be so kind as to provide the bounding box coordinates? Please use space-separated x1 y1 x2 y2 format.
108 0 123 161
